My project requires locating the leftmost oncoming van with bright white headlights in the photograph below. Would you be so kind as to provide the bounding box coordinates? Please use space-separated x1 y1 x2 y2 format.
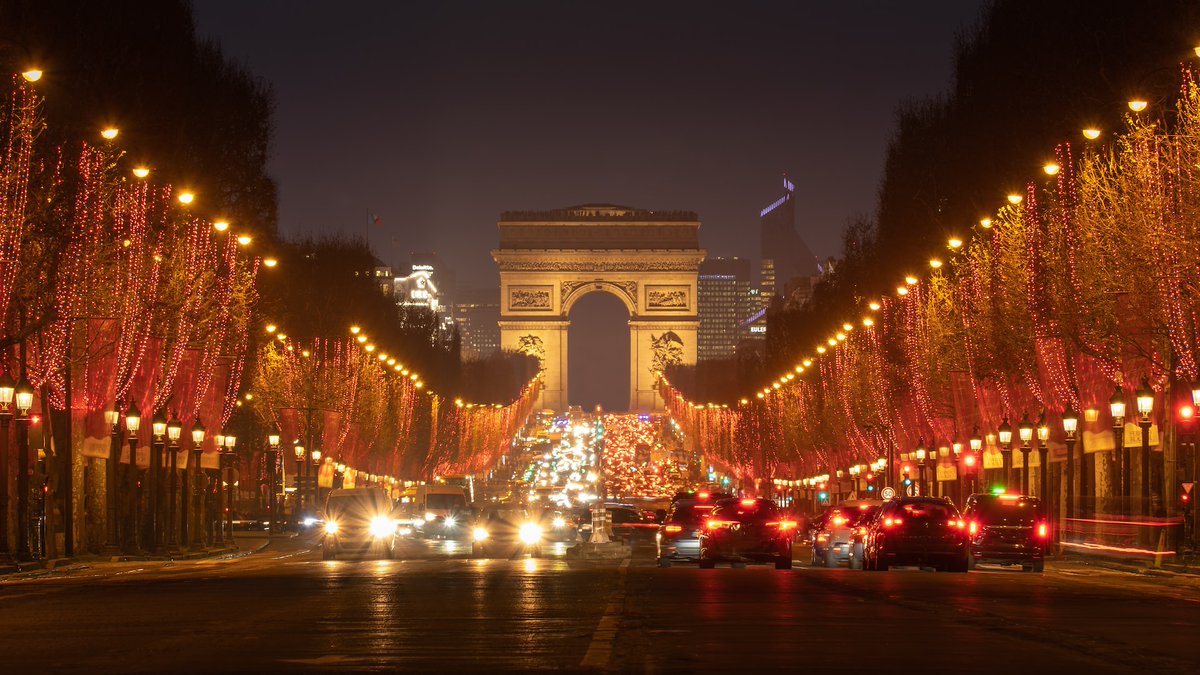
320 488 400 560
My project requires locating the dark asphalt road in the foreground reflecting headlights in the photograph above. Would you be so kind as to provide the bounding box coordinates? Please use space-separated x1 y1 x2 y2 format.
0 539 1200 674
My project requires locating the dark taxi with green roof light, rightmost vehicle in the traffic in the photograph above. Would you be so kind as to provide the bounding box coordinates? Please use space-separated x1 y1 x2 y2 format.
962 494 1050 573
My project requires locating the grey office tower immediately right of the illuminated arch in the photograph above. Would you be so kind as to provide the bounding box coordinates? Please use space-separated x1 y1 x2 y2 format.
696 258 754 360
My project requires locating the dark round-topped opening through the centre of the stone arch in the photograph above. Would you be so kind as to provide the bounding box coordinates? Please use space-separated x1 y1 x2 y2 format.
566 291 630 412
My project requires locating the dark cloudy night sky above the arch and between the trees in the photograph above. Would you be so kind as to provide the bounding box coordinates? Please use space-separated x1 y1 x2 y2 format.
196 0 982 286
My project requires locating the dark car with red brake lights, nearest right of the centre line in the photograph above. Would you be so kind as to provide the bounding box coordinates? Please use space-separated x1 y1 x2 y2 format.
698 497 796 569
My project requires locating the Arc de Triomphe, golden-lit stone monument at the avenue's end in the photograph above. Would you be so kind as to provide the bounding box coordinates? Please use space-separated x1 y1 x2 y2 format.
492 204 704 412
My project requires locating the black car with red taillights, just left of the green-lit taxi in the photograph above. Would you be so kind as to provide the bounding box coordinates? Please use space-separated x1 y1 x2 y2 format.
863 497 968 572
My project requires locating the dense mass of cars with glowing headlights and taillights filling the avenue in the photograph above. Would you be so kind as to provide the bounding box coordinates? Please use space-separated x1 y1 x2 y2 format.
312 414 1050 573
